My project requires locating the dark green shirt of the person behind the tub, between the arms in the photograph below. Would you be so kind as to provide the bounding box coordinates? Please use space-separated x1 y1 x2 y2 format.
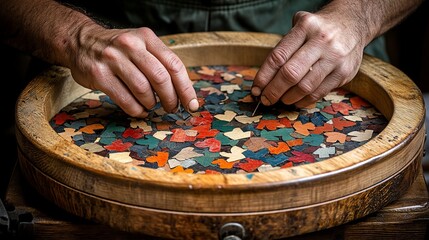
62 0 388 61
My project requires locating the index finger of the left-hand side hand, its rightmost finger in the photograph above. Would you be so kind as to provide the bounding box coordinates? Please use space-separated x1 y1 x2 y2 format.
143 28 199 112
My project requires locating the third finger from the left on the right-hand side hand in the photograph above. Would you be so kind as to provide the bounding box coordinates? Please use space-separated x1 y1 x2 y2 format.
281 60 335 105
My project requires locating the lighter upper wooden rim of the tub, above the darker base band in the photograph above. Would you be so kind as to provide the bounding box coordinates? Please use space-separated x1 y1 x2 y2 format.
16 32 425 213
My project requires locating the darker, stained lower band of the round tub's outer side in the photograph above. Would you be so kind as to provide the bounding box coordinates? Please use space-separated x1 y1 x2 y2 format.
15 145 421 239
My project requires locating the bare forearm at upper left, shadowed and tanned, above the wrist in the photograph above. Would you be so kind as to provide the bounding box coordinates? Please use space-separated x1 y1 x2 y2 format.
0 0 101 65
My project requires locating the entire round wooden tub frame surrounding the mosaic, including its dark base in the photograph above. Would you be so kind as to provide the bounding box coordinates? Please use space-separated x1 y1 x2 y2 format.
16 32 425 239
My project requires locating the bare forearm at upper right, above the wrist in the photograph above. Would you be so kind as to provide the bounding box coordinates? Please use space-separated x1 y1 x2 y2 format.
319 0 423 45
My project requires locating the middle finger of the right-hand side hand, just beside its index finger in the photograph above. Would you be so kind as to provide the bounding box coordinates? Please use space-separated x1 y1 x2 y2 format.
261 39 322 106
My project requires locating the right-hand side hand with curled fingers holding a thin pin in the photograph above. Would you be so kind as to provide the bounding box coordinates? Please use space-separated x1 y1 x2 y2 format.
252 11 366 107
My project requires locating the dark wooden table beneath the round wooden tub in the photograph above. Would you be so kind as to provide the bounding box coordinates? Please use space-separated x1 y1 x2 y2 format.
6 163 429 240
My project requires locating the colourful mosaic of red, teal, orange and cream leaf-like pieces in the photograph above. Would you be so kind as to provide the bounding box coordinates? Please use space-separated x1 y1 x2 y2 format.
50 66 387 174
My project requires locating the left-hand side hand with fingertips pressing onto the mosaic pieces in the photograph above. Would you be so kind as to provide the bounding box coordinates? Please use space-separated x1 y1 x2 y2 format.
69 24 199 117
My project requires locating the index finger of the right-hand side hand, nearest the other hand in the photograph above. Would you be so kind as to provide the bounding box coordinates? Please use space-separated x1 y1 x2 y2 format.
251 25 306 96
